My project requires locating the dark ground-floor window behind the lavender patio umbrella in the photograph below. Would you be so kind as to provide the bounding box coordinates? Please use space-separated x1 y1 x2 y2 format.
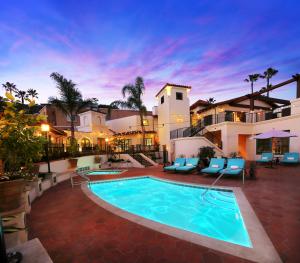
256 138 290 155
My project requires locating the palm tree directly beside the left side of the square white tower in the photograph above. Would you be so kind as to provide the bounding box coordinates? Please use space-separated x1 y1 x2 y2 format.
110 77 147 150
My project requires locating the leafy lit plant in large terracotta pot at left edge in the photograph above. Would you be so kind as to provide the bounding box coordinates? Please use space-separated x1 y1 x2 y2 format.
0 92 45 212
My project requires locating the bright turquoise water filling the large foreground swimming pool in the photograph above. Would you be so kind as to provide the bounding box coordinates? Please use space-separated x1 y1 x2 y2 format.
90 177 252 247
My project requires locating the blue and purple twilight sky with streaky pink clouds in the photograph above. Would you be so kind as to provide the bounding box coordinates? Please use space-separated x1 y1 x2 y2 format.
0 0 300 108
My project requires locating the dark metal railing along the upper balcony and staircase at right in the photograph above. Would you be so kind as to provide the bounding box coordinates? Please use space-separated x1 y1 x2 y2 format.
170 106 291 139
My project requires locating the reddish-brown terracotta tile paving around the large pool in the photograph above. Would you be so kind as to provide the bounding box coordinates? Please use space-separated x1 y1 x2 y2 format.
28 166 300 263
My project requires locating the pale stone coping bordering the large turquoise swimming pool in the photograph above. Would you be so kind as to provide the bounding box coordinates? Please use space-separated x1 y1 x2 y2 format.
81 175 282 262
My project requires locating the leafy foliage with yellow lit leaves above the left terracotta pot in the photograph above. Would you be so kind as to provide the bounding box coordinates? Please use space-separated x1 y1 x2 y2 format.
0 92 45 173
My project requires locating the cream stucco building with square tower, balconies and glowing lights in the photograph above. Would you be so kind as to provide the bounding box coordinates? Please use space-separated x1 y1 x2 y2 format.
41 75 300 160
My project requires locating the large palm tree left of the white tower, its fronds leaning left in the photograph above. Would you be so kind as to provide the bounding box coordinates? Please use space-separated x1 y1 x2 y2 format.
48 72 92 141
